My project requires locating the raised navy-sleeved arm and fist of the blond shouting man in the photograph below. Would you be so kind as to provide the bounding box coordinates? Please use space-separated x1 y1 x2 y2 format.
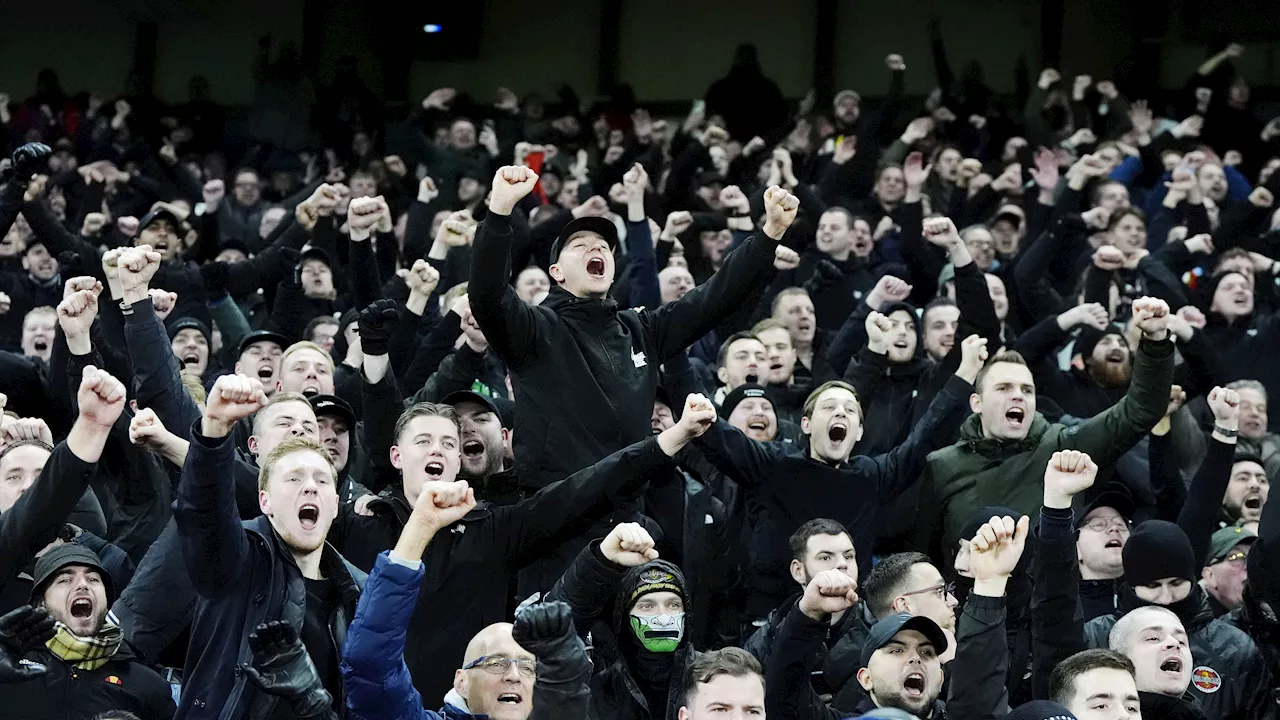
173 375 266 598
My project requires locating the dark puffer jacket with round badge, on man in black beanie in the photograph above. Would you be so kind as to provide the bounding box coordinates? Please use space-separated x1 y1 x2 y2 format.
1084 584 1275 720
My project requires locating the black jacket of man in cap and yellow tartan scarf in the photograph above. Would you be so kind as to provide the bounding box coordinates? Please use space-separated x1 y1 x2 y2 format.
0 644 174 720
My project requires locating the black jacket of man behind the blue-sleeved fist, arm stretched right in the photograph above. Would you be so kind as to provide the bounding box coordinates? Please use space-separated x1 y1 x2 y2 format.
329 430 672 702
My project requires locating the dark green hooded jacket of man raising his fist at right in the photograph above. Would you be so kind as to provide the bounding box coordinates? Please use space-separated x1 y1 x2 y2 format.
918 340 1174 553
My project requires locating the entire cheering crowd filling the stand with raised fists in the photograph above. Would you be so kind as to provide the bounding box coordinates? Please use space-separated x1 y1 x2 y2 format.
0 32 1280 720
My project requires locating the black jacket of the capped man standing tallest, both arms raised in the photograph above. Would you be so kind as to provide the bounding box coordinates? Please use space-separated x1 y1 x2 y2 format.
467 207 778 487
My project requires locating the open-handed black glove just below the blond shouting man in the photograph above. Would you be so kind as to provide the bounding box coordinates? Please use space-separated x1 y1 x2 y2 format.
241 620 334 717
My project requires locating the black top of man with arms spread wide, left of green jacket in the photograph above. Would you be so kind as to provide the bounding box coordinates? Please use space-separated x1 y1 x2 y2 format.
695 375 973 616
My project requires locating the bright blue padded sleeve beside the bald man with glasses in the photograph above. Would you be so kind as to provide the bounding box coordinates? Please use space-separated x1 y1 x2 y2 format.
342 552 471 720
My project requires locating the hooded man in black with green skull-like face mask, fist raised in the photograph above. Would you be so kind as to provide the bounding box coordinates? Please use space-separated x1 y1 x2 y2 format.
549 523 698 720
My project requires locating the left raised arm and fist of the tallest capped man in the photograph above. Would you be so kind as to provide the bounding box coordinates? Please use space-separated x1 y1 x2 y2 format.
467 165 538 369
